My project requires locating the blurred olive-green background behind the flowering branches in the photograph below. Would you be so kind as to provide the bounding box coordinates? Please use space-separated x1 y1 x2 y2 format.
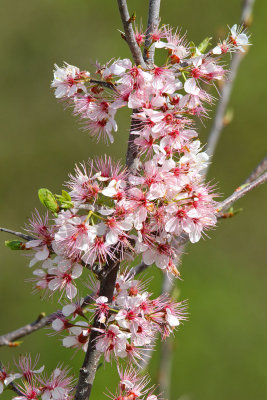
0 0 267 400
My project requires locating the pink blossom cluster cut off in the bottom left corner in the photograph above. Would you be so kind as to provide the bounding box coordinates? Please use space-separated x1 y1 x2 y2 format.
0 355 74 400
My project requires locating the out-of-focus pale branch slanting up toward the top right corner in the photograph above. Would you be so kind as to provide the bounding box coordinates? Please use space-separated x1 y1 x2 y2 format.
207 0 255 170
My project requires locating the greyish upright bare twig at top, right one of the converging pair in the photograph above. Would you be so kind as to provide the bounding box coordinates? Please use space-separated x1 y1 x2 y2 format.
144 0 160 65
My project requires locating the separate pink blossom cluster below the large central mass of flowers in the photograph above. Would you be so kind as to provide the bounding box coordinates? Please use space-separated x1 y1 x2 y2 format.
52 273 186 363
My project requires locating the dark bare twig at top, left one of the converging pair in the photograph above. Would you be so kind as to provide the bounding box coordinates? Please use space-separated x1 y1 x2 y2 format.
117 0 146 68
